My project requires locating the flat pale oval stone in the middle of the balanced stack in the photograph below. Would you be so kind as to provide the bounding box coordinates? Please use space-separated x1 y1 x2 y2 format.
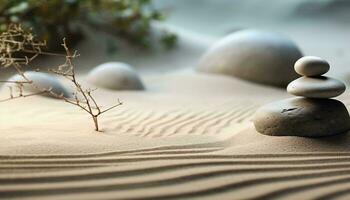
287 76 345 98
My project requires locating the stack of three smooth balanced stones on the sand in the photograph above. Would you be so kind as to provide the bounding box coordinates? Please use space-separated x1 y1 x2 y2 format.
254 56 350 137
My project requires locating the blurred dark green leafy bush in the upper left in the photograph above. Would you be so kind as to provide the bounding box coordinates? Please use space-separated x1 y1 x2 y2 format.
0 0 176 48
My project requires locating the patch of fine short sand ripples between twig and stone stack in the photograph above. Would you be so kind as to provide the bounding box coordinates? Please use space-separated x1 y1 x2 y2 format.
108 103 256 137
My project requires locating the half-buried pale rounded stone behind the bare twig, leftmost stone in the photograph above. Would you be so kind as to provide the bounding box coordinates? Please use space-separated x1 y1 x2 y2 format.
5 71 72 98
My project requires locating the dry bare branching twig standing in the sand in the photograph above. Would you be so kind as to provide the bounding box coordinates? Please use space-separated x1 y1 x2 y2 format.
0 25 122 131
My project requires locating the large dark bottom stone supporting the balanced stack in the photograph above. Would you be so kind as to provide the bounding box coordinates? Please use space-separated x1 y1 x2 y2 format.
254 97 350 137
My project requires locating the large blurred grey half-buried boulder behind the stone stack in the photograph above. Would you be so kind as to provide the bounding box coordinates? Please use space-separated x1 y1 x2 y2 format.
197 30 302 87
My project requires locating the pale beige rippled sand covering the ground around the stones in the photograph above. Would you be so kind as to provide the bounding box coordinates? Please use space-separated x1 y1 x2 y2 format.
0 1 350 199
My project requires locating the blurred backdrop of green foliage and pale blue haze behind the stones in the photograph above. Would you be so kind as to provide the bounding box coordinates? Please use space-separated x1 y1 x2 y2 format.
0 0 350 81
